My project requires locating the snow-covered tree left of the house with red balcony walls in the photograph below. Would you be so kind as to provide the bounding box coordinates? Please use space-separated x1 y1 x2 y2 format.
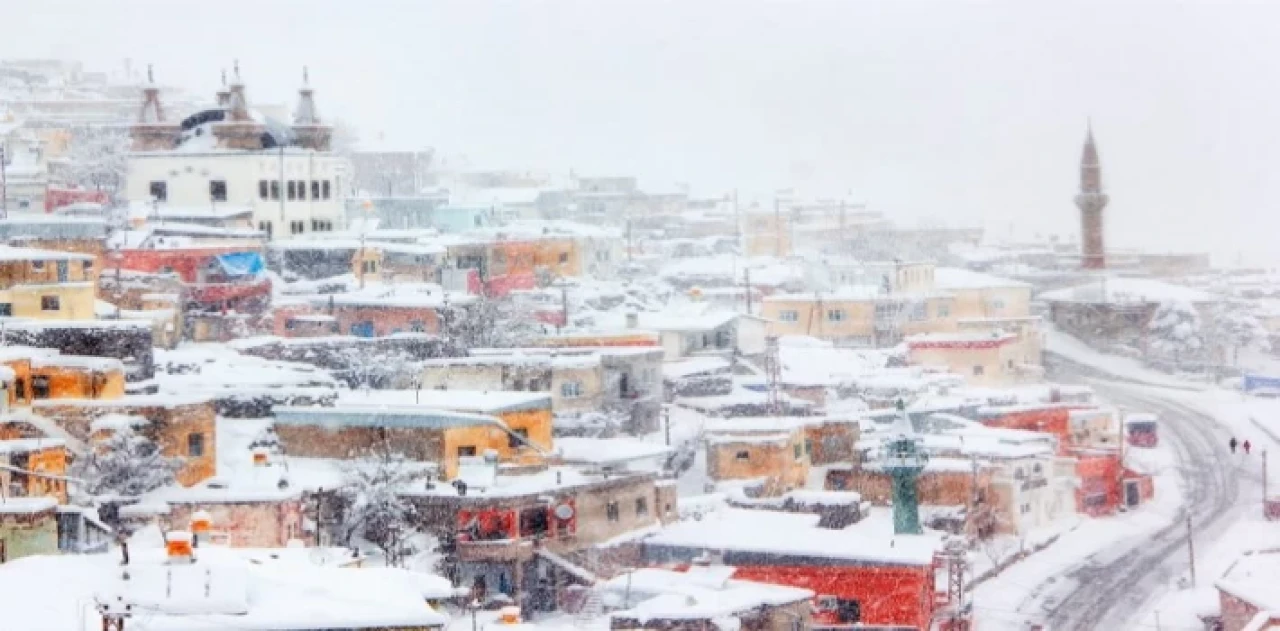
338 451 425 566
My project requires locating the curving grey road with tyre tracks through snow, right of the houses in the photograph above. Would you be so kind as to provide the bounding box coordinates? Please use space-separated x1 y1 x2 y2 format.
1041 356 1239 631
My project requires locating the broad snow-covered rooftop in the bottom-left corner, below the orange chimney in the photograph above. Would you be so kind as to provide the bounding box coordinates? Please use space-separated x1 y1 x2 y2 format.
0 544 448 631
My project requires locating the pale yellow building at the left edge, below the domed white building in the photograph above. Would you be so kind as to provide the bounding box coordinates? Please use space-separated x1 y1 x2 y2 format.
0 246 97 320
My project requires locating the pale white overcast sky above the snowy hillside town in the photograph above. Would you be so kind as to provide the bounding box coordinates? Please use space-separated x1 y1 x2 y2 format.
10 0 1280 262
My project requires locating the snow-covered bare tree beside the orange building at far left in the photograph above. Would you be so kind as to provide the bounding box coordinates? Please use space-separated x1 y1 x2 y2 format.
70 426 182 498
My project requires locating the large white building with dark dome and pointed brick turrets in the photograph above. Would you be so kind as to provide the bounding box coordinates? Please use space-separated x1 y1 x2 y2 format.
125 69 349 237
